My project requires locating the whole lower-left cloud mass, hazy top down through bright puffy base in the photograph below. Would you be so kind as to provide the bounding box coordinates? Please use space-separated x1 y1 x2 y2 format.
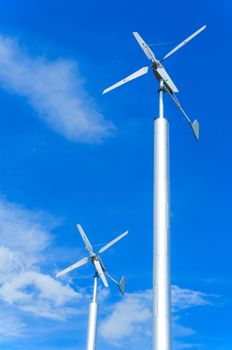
0 199 82 326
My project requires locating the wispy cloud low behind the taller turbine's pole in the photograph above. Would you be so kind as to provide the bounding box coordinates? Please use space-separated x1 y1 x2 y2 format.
100 286 211 348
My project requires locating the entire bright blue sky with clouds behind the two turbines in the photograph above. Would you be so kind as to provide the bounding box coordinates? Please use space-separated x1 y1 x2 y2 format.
0 0 232 350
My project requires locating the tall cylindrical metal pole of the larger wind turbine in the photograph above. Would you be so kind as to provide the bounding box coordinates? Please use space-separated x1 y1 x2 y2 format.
152 80 171 350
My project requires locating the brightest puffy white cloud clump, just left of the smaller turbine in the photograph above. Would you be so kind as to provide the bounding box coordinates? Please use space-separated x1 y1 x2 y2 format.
0 271 81 319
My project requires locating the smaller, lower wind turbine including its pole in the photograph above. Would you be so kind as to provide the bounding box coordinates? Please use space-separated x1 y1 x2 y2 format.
56 224 128 350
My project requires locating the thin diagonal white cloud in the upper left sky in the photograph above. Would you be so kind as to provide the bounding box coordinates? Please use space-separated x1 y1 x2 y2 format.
0 36 113 142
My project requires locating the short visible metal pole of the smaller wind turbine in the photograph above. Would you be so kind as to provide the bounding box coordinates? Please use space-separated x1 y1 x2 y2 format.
87 276 98 350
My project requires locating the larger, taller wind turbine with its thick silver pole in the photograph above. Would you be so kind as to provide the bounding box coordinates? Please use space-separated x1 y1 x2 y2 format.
103 25 206 350
